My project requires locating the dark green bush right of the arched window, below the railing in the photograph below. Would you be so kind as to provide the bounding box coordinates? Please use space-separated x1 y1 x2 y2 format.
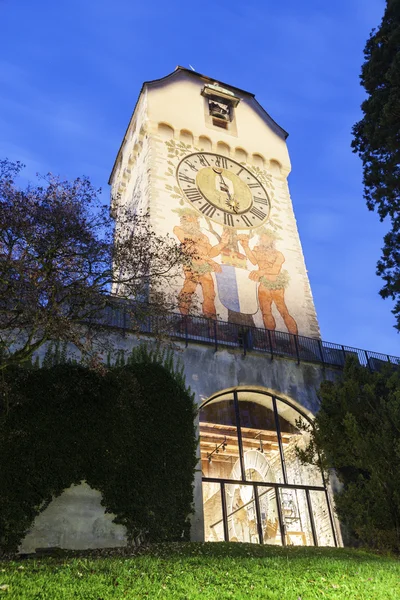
297 358 400 551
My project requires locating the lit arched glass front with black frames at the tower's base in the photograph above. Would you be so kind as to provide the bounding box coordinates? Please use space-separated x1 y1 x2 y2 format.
200 388 338 546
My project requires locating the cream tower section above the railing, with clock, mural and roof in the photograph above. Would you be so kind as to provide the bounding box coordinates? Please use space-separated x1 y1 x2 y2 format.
110 67 320 338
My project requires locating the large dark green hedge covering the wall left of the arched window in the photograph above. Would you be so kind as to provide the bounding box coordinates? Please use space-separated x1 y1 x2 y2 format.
0 348 197 551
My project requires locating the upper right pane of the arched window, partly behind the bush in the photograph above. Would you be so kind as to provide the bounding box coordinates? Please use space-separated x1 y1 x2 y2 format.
276 398 323 487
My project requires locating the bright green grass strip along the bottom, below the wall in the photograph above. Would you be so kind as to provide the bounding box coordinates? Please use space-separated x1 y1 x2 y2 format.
0 544 400 600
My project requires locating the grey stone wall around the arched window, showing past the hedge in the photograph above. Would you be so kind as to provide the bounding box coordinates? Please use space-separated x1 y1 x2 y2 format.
22 332 340 552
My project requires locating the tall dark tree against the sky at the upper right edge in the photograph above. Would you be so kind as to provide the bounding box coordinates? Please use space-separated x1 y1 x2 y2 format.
352 0 400 330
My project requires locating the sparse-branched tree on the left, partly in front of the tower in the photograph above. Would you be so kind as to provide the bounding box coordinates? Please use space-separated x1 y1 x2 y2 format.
0 160 185 368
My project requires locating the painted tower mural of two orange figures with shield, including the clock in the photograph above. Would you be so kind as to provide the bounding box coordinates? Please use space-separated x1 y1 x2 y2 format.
165 140 298 334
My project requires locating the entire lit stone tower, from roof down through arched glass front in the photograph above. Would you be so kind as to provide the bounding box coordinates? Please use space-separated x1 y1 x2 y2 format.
110 67 345 545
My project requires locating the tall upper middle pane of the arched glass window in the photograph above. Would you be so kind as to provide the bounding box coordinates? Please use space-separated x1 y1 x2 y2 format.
238 391 283 483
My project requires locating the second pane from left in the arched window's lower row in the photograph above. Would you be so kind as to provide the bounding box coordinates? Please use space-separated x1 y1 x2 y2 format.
225 483 260 544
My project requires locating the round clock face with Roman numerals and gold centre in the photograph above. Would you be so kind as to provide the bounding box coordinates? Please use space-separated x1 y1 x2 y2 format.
176 152 270 229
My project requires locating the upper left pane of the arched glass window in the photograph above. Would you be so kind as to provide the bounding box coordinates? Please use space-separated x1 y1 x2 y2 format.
200 397 242 479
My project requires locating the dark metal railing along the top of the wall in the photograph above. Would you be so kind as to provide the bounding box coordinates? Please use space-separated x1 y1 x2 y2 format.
92 298 400 371
